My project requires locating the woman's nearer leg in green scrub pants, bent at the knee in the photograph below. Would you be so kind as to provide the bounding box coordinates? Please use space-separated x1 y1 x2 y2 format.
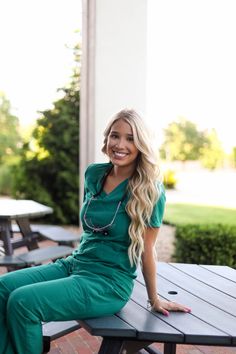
7 275 126 354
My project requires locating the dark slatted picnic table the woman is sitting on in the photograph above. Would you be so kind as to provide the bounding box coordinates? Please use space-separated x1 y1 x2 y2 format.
79 262 236 354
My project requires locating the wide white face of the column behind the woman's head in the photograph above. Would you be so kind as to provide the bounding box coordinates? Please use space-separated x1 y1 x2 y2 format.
94 0 147 161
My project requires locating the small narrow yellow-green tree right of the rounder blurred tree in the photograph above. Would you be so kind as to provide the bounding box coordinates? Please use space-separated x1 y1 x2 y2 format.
200 129 224 170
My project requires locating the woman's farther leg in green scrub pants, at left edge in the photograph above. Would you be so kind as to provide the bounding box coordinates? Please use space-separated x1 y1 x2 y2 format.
0 263 68 354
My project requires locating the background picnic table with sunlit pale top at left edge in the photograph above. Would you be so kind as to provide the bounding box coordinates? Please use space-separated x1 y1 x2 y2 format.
0 199 53 255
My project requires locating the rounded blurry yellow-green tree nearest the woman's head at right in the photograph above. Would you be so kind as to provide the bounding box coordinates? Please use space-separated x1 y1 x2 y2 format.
160 117 206 161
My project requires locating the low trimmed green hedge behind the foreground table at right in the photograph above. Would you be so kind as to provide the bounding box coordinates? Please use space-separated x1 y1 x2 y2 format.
174 224 236 268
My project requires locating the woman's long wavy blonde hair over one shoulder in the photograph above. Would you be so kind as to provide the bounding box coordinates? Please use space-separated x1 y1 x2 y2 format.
102 109 160 266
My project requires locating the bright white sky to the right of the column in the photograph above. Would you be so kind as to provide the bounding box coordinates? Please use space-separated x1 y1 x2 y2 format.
147 0 236 150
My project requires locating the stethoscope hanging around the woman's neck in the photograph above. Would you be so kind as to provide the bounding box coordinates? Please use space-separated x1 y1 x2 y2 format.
83 166 127 236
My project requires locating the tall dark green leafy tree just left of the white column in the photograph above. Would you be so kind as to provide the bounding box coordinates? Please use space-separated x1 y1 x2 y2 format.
12 41 80 224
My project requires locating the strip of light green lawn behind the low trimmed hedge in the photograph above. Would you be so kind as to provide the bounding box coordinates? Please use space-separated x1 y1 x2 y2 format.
164 203 236 225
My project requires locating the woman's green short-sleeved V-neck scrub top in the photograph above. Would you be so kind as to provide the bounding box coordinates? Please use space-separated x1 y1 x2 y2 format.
73 163 165 297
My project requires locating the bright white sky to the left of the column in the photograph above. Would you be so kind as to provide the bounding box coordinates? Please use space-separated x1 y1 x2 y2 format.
0 0 82 126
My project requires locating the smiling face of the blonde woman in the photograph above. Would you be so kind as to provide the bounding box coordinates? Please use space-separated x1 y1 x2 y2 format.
107 119 139 167
